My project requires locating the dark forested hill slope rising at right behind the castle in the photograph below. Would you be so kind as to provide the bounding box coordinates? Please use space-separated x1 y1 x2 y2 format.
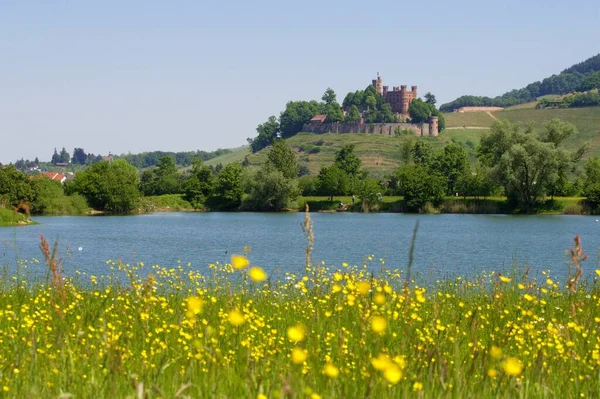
440 54 600 112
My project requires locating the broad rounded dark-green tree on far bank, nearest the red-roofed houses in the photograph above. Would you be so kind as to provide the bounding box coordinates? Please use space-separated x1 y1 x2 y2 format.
69 159 140 213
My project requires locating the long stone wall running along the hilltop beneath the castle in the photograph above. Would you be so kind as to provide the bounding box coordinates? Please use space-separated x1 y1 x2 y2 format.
302 123 438 136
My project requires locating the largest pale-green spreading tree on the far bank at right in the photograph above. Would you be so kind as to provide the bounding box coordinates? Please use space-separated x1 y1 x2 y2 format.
478 121 583 213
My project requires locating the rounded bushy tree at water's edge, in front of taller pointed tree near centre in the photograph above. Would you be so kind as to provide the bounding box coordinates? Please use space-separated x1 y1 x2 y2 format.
244 163 300 211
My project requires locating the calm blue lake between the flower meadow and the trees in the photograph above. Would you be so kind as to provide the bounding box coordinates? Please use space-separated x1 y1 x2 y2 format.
0 212 600 281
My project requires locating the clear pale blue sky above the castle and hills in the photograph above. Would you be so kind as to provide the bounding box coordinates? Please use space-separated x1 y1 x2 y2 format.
0 0 600 163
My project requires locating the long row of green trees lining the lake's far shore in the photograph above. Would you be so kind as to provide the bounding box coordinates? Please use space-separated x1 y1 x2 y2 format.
0 119 600 213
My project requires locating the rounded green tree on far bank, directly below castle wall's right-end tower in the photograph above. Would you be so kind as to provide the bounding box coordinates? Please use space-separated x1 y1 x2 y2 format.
395 165 448 210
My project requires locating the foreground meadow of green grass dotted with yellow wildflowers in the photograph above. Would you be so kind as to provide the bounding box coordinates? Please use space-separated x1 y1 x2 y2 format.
0 223 600 399
